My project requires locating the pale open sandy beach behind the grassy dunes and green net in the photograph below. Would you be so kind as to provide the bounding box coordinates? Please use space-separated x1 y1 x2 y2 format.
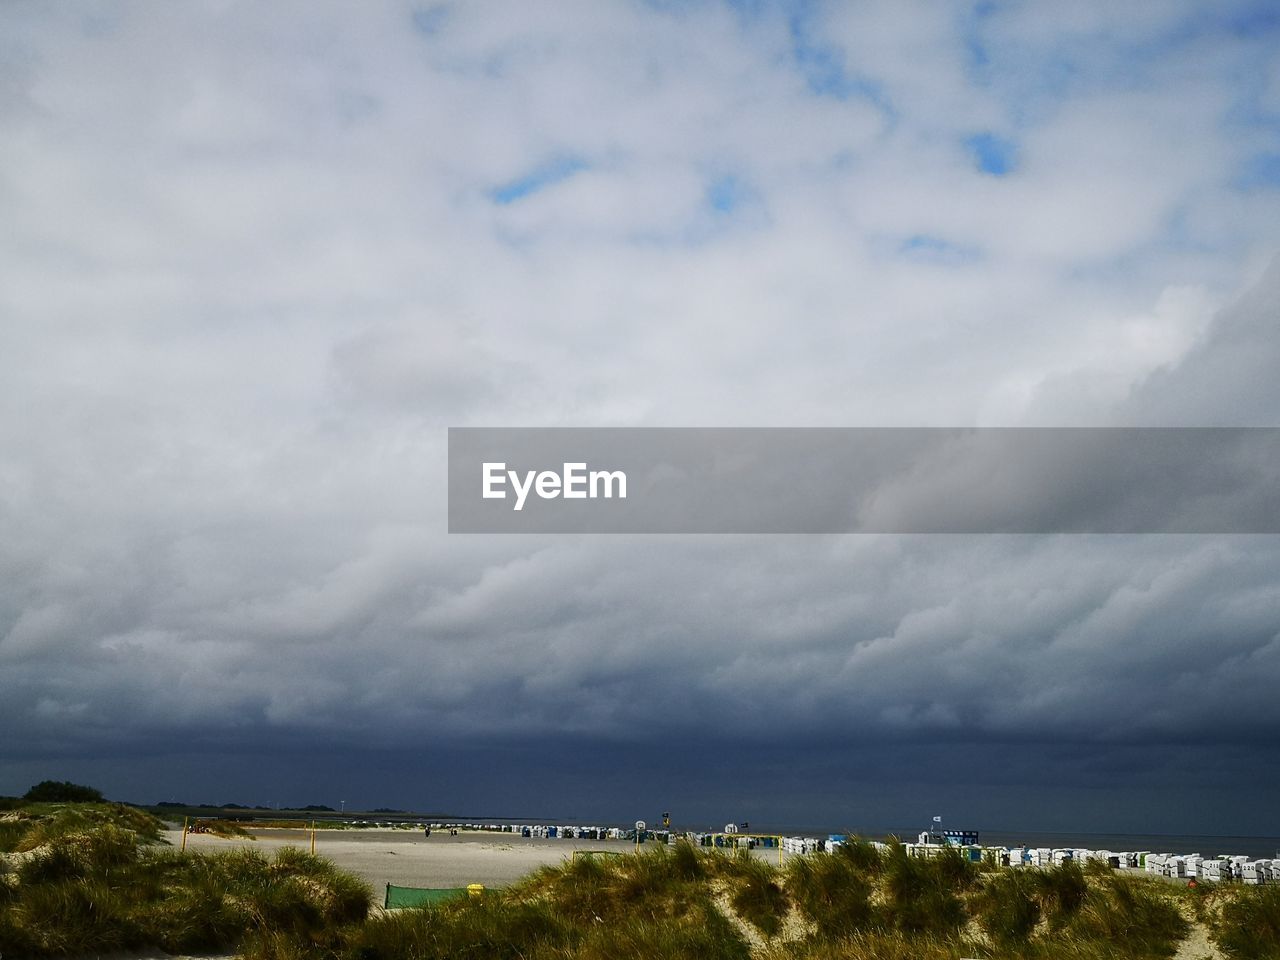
165 828 635 901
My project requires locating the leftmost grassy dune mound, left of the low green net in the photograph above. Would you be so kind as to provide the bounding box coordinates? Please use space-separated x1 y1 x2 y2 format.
0 818 371 957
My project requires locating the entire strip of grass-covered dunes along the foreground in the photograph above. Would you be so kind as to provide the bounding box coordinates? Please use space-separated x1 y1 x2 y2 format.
0 804 1280 960
